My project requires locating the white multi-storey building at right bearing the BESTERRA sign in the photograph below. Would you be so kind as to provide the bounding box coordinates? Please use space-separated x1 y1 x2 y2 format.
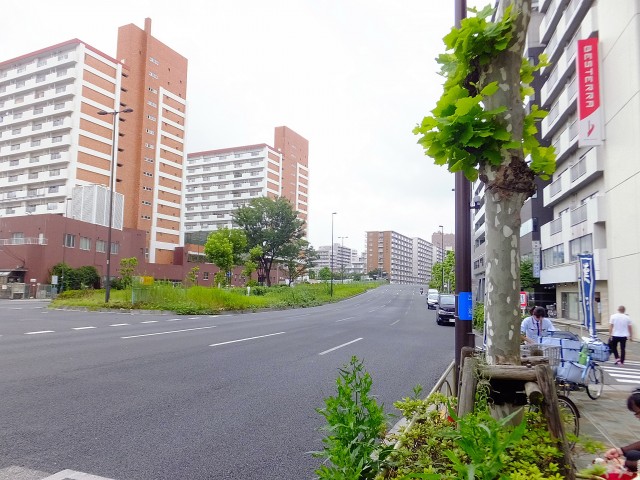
537 0 640 331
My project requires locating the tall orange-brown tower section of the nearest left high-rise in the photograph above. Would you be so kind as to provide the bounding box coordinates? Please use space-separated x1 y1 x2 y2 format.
116 18 187 263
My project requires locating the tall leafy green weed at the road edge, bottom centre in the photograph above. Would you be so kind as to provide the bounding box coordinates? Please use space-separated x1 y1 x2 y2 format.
314 356 391 480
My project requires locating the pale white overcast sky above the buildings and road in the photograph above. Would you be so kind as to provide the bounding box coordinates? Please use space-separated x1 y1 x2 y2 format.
0 0 489 251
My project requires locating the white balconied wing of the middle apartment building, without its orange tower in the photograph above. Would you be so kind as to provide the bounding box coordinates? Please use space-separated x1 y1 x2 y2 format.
184 143 282 238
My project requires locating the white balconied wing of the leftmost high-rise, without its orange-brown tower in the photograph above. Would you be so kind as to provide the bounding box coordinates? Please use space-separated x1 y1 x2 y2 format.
0 40 126 219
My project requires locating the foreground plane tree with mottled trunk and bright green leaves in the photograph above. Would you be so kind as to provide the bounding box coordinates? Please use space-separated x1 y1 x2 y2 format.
414 0 555 365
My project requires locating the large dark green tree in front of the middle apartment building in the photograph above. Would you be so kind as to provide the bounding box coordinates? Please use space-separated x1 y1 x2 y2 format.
233 197 305 286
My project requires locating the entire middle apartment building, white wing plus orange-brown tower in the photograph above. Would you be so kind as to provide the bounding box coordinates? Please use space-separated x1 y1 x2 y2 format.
184 127 309 243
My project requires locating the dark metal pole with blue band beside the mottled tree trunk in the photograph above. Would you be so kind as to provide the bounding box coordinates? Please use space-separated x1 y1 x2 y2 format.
454 0 475 390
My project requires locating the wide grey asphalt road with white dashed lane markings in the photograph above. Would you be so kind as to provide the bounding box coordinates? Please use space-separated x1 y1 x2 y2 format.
0 285 454 480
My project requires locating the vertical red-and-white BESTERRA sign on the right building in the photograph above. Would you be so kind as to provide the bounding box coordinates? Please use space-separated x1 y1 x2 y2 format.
576 38 604 147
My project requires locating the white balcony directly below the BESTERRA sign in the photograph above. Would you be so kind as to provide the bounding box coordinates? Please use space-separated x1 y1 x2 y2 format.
542 148 604 207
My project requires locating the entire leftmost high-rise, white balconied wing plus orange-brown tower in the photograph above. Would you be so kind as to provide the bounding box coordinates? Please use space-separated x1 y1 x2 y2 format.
0 19 187 263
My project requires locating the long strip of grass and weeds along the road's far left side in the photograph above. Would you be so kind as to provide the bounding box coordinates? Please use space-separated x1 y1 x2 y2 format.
51 282 381 315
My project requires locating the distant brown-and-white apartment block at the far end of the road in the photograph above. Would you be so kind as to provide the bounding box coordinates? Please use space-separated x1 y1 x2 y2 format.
365 230 428 284
